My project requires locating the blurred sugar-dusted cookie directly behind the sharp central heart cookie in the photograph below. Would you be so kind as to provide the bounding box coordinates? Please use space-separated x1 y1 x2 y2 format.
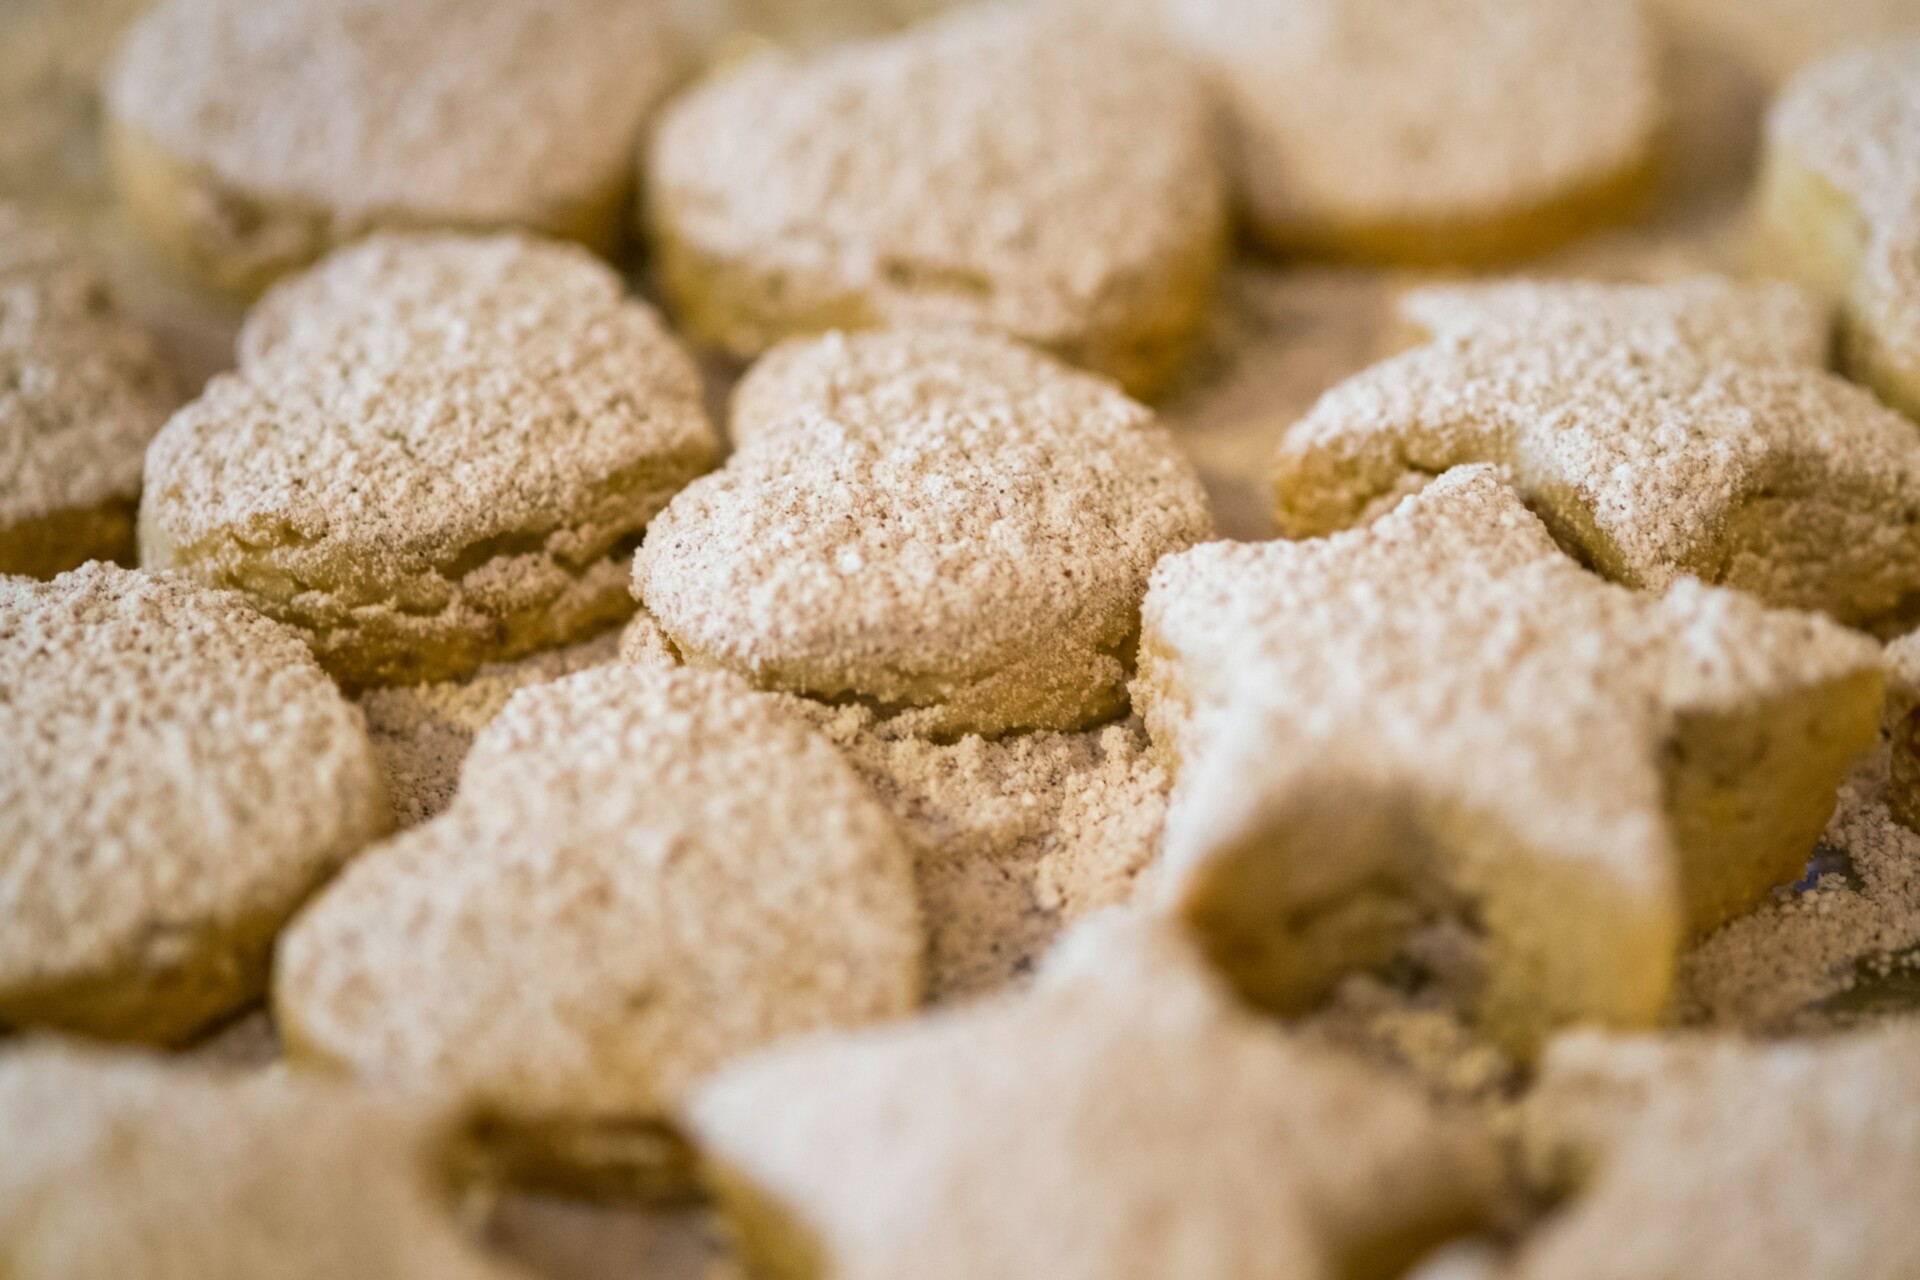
645 4 1227 393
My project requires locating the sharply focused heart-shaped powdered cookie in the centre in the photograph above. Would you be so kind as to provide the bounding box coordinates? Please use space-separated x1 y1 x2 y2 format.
634 330 1212 737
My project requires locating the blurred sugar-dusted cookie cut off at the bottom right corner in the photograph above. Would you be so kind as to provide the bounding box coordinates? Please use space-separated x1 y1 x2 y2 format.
1501 1027 1920 1280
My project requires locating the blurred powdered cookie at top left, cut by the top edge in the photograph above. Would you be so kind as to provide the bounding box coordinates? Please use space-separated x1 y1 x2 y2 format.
106 0 676 294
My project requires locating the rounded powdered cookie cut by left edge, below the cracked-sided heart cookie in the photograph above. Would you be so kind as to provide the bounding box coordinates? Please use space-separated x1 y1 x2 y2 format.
0 564 388 1044
